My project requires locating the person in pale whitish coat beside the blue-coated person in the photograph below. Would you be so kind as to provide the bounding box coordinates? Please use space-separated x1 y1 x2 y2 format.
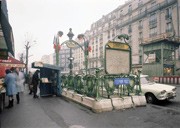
14 68 25 104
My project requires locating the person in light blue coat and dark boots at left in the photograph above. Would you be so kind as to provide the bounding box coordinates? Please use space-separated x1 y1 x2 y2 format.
4 69 17 108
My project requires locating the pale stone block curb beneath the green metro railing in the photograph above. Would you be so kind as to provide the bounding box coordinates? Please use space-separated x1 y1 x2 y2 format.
62 89 146 113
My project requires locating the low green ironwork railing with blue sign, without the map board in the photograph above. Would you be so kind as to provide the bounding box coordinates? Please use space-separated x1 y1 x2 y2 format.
61 68 141 98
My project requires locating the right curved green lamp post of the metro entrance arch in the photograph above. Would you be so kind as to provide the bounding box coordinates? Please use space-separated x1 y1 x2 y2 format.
77 34 90 75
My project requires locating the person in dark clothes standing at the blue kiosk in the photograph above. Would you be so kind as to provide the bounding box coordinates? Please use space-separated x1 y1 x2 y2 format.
32 70 40 98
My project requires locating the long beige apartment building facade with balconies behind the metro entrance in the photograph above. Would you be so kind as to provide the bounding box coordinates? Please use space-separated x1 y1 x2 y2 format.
69 0 180 76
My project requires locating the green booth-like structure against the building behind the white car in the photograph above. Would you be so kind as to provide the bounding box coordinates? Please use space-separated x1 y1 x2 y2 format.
142 39 179 76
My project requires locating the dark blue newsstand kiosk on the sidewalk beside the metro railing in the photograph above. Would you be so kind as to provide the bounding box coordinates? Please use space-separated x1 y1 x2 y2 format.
32 62 61 96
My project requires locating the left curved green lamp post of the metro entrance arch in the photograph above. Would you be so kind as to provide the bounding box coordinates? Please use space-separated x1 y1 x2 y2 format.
53 31 63 66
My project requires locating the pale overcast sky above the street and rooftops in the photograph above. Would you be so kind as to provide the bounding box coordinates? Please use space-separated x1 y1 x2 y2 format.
7 0 126 63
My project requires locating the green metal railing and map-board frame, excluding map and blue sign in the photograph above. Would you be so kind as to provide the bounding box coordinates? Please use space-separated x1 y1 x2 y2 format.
61 35 141 99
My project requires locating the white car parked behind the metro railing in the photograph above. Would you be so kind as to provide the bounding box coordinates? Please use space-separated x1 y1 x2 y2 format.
140 75 176 103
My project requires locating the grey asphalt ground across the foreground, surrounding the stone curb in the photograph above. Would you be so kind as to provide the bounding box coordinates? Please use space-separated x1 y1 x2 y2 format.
1 85 180 128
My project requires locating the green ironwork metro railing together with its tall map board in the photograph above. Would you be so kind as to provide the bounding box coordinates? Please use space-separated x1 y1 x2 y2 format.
61 34 141 99
